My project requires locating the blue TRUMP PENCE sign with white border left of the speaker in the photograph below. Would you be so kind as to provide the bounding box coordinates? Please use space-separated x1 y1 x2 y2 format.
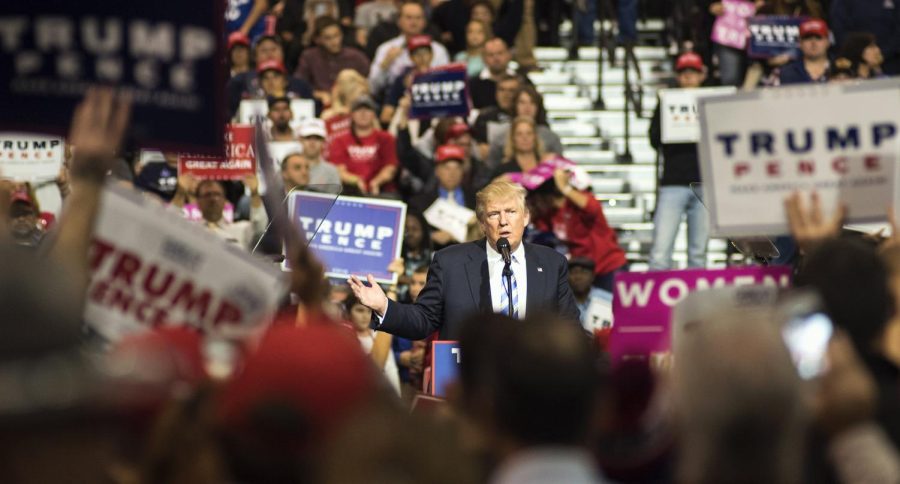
283 191 406 284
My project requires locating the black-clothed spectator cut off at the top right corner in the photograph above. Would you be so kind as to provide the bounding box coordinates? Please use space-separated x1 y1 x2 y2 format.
831 0 900 75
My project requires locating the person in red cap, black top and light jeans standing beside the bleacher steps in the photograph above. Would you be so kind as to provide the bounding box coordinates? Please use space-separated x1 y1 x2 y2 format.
649 52 709 270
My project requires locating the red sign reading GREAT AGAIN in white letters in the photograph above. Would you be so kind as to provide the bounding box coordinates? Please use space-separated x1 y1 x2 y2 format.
178 124 256 180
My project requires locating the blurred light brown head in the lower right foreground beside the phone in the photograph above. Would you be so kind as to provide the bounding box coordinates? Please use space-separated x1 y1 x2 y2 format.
673 312 806 484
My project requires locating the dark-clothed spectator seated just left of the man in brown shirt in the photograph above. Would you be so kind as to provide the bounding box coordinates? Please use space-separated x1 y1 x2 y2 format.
225 35 321 118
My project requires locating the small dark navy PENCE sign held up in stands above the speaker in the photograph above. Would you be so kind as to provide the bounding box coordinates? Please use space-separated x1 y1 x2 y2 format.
409 64 469 119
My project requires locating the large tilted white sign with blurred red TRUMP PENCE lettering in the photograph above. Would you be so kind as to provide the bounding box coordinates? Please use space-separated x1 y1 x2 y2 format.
84 185 286 341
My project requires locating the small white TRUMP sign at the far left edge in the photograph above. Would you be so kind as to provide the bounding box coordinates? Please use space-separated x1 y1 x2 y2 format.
0 133 66 182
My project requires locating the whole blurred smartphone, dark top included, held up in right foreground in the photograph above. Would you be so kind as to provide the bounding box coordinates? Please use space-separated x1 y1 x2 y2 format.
781 293 834 380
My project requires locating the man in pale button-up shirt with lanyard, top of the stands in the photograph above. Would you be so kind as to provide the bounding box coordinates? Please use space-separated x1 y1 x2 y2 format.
369 0 450 95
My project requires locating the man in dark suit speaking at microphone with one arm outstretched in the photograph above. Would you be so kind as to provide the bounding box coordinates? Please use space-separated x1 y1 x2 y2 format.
348 181 578 339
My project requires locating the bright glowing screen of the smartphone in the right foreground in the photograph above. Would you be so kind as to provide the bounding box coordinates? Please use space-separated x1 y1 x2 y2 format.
782 312 834 380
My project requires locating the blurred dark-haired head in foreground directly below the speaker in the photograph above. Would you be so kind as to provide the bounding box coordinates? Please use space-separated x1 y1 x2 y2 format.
460 315 598 452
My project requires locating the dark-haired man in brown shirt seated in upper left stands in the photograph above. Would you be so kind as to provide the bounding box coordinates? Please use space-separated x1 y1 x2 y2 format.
294 16 369 105
